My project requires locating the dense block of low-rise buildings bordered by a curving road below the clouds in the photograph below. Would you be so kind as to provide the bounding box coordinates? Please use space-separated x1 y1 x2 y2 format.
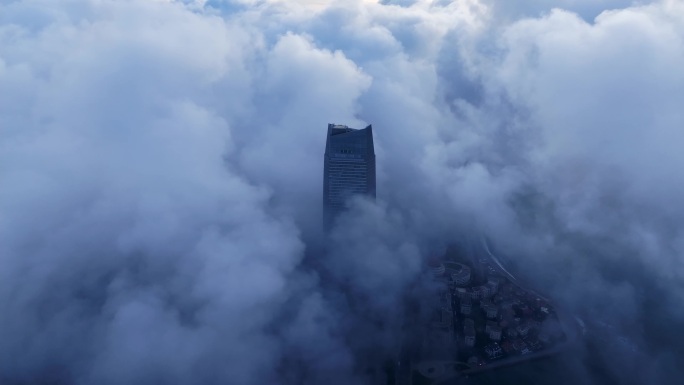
431 262 563 366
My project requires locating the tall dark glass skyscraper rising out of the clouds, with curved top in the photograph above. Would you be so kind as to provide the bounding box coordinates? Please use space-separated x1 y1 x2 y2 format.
323 124 375 225
